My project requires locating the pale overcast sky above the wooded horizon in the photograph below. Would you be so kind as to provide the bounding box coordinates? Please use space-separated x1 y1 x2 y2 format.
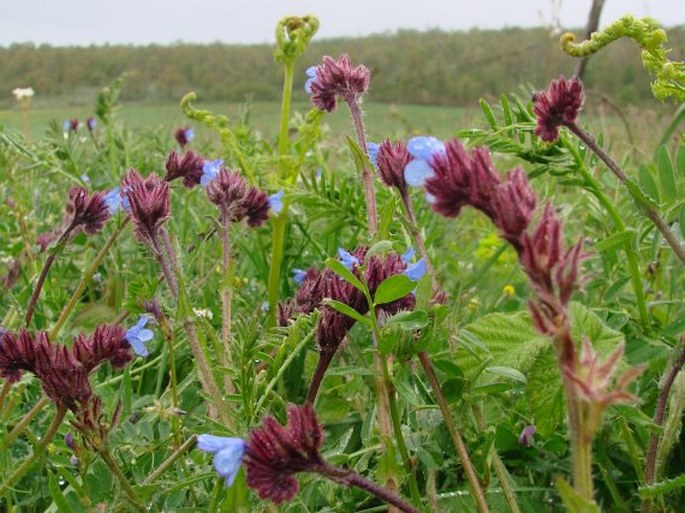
0 0 685 46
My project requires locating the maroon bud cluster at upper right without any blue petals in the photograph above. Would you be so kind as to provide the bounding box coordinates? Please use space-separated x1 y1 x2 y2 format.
533 76 583 142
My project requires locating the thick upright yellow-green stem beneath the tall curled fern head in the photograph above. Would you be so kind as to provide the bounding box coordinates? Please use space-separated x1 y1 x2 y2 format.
267 59 295 326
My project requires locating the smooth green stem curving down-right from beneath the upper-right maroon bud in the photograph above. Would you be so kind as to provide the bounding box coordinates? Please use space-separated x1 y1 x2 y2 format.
562 137 649 327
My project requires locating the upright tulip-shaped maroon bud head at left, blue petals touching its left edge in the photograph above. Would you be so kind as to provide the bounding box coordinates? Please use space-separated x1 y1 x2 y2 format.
121 169 170 243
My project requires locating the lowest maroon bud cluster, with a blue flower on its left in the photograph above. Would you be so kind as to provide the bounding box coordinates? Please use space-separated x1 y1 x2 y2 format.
243 404 324 504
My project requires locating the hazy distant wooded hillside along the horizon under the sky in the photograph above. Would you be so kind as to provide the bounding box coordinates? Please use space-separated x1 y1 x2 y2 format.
0 26 685 108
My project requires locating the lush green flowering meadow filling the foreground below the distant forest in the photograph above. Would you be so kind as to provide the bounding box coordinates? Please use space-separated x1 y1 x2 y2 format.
0 12 685 513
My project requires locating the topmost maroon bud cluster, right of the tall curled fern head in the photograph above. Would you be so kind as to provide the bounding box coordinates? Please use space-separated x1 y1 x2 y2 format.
311 55 371 112
